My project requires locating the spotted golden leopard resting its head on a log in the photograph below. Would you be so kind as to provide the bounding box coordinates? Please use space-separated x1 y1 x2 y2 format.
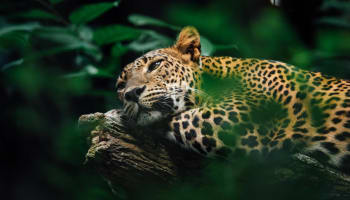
116 26 350 174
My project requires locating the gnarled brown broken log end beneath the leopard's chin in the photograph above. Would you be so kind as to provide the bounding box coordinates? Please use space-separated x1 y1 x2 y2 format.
79 110 204 196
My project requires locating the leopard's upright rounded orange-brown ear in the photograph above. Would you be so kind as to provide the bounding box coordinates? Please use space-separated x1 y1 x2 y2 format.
174 26 201 62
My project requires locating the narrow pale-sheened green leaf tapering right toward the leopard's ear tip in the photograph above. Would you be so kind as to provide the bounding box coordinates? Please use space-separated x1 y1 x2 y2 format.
128 14 181 31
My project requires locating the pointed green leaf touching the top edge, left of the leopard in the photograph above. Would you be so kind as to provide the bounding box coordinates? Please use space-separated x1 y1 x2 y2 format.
69 1 119 24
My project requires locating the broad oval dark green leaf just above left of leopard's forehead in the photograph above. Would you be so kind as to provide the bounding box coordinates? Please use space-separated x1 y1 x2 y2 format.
94 25 141 45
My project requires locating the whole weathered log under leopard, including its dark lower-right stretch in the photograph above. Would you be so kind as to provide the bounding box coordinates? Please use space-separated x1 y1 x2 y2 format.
79 110 350 200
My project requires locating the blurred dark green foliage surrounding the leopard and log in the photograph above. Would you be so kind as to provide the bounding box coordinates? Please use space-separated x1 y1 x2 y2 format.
0 0 350 200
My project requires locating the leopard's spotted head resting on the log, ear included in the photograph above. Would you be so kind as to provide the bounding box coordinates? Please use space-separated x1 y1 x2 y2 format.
117 27 201 125
